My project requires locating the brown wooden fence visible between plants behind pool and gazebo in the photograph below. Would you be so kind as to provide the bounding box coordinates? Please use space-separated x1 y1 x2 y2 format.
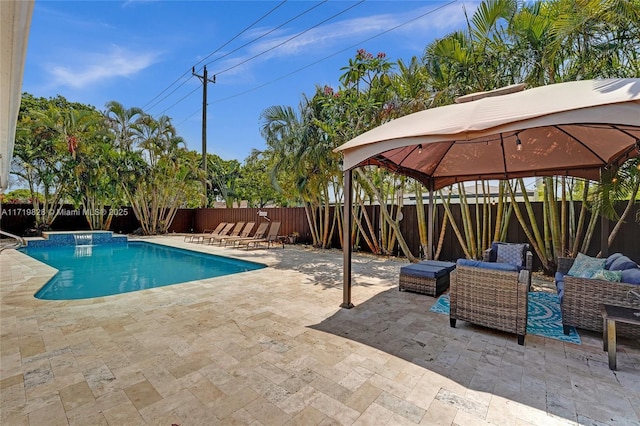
0 202 640 269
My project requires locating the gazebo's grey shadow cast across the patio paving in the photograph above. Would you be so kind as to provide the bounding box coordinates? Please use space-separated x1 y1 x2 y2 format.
312 287 640 424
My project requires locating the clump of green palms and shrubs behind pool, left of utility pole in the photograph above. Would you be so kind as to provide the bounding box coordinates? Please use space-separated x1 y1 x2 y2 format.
12 93 201 234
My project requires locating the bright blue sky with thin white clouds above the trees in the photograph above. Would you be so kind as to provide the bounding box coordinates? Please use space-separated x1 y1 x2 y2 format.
23 0 476 162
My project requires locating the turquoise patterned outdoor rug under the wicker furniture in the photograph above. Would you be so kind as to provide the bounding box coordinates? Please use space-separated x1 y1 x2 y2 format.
429 291 582 345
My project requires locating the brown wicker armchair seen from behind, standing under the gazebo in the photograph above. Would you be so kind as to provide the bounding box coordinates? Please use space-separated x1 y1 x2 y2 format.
449 265 531 345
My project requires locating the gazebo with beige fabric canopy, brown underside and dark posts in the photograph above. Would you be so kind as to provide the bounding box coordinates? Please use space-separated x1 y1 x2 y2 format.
335 78 640 308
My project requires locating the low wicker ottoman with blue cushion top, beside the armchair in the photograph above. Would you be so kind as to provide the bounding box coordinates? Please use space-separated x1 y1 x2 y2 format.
398 260 456 297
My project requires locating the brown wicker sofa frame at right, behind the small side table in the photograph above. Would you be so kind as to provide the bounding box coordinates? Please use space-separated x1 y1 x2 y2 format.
558 257 640 339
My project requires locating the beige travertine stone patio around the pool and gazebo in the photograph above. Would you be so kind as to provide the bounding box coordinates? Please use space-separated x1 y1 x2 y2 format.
0 236 640 426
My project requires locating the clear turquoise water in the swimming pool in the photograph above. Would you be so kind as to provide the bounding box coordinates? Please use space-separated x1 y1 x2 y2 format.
21 241 265 300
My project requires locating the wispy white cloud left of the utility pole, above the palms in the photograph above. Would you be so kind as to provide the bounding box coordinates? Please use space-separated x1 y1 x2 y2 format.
46 46 159 89
